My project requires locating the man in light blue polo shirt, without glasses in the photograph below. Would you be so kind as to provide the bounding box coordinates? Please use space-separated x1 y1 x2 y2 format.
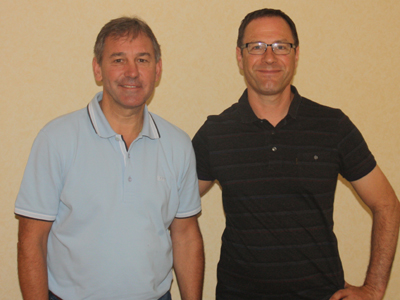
15 18 204 300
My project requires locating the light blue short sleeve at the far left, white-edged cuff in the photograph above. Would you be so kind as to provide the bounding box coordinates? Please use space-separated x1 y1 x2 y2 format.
15 130 62 221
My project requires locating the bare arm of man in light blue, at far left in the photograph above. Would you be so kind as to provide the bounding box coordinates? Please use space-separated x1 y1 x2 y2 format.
18 216 53 300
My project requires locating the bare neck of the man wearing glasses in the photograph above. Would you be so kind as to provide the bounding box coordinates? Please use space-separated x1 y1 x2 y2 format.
247 86 294 127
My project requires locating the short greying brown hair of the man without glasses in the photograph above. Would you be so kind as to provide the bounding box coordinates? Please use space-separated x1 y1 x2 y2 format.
94 17 161 64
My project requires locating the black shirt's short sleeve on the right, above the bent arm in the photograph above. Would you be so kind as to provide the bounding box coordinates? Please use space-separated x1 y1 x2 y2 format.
338 115 376 181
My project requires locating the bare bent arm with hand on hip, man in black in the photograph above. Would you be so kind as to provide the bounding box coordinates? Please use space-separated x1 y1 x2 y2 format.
331 166 400 300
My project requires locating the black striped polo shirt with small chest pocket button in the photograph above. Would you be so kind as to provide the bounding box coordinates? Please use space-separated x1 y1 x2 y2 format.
193 86 376 300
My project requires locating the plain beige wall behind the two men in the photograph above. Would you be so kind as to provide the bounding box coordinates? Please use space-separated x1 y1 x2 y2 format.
0 0 400 300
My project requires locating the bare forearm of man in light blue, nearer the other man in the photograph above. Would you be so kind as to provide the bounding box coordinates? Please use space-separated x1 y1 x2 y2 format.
170 216 204 300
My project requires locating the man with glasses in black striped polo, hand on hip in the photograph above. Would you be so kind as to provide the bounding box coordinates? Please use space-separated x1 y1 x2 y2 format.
193 9 400 300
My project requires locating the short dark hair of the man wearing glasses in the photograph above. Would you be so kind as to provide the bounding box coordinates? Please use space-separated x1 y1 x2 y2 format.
237 8 299 48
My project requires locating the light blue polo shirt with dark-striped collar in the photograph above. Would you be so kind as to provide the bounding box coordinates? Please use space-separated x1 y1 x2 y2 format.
15 92 201 300
